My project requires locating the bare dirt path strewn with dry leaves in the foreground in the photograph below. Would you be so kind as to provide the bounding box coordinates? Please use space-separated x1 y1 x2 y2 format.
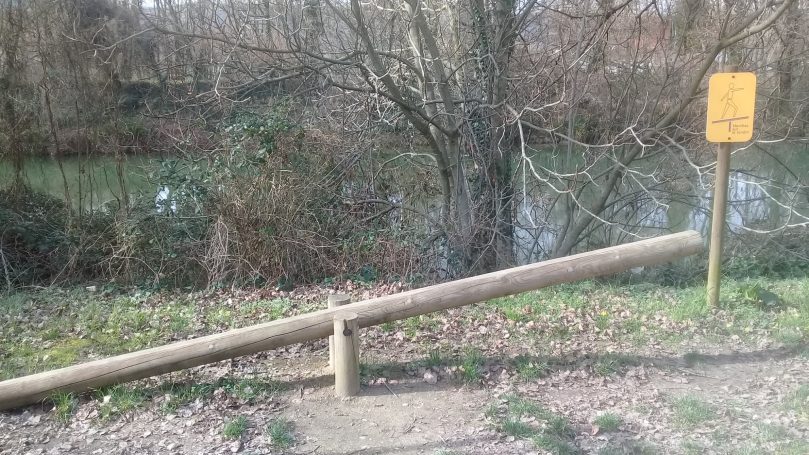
0 349 809 455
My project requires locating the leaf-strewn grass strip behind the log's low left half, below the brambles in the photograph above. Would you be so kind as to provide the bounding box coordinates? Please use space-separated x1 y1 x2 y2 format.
0 288 310 380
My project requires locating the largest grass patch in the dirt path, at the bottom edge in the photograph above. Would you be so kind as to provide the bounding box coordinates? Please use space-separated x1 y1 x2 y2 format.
486 395 580 455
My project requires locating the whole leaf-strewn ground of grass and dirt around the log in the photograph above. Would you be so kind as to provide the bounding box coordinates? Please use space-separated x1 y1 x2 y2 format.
0 278 809 454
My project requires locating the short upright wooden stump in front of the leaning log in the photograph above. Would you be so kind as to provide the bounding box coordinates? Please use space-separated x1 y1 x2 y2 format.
334 313 360 397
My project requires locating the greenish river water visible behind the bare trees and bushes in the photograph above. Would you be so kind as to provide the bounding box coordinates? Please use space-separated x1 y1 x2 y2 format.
0 146 809 263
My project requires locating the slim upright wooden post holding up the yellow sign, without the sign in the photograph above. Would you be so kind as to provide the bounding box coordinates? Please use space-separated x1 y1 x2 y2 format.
707 65 738 307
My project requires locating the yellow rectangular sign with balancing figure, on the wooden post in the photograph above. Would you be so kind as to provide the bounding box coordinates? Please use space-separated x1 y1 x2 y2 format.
705 73 756 142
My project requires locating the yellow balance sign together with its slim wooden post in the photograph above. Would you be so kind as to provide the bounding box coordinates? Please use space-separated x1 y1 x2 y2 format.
705 66 756 306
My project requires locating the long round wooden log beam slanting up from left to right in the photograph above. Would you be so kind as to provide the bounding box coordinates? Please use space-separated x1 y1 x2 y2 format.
0 231 703 410
